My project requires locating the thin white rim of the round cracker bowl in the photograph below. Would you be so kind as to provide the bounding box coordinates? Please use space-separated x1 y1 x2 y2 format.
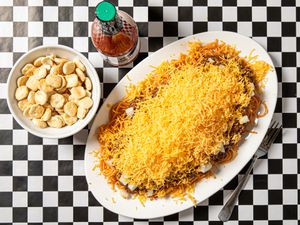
6 44 101 139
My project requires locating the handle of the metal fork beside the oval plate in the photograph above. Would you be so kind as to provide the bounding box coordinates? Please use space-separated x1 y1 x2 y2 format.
218 155 258 222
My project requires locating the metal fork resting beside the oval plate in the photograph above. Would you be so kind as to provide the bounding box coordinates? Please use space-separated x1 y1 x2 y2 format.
218 121 282 222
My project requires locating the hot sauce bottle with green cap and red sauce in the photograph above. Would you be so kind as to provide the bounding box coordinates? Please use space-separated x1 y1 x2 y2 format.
92 1 140 66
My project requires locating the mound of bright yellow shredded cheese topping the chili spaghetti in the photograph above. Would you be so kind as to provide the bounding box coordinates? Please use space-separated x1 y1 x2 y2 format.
99 40 270 196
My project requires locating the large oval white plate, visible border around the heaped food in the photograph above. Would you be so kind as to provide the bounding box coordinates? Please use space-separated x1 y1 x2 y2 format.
85 32 277 219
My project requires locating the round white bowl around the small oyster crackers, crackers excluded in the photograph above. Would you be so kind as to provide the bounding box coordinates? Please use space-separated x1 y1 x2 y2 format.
7 45 101 138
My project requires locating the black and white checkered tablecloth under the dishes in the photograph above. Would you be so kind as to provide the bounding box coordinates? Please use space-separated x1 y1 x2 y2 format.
0 0 300 225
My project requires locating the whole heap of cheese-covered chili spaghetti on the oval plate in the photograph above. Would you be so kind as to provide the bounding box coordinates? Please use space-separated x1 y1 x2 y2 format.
97 41 270 202
